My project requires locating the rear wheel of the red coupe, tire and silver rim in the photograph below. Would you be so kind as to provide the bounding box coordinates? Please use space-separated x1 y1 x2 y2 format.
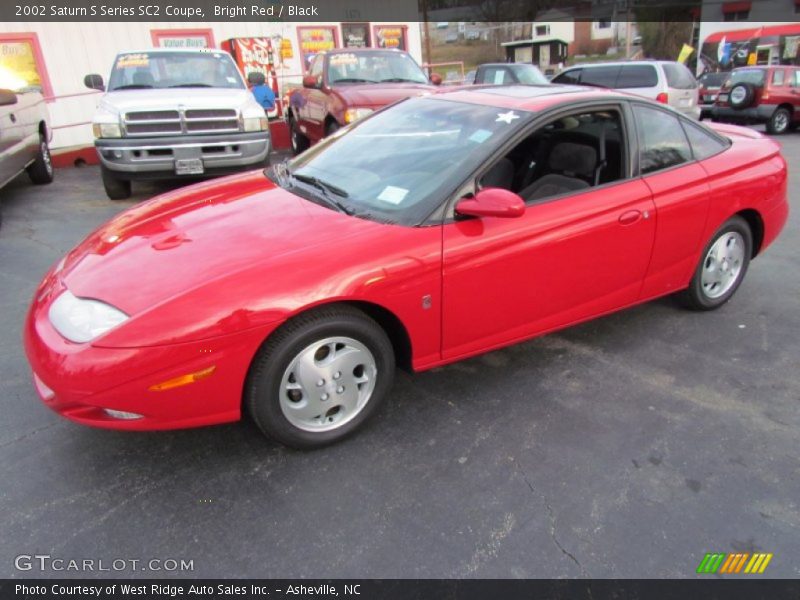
682 216 753 310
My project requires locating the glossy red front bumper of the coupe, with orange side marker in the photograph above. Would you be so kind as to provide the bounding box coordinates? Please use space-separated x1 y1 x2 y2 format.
23 276 278 431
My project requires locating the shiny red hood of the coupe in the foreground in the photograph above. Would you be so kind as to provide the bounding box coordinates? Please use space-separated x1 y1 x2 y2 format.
60 171 380 315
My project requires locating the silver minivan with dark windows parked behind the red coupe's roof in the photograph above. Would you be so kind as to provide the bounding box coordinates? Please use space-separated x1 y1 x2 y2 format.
552 60 700 119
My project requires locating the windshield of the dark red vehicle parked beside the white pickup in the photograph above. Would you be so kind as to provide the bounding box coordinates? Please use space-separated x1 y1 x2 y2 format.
328 51 428 85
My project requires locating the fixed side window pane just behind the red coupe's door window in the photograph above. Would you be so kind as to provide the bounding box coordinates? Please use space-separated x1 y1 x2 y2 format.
633 104 692 175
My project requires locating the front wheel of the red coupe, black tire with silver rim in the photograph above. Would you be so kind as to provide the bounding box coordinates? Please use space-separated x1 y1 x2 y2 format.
245 306 395 449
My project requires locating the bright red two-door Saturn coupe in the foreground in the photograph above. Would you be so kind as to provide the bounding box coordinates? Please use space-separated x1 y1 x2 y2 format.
24 86 788 448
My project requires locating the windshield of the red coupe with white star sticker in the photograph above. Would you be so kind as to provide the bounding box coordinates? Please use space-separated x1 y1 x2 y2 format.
272 98 533 225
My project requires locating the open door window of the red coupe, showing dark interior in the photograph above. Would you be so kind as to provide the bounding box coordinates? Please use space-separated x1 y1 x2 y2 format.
478 109 627 204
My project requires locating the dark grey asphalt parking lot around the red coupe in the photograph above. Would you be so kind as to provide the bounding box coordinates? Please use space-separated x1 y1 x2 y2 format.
0 133 800 578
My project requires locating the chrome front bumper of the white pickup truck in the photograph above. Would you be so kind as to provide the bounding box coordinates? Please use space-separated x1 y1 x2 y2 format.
95 131 270 179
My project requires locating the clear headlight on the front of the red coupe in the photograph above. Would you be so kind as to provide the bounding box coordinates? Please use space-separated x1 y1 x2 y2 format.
49 290 128 343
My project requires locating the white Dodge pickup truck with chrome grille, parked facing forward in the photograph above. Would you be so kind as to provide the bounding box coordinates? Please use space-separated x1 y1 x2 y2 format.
84 49 270 200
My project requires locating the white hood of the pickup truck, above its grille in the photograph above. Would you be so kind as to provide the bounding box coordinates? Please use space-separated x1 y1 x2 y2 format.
100 88 252 113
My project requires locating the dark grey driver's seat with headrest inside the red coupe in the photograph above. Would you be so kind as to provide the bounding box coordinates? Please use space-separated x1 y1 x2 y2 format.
520 142 597 202
